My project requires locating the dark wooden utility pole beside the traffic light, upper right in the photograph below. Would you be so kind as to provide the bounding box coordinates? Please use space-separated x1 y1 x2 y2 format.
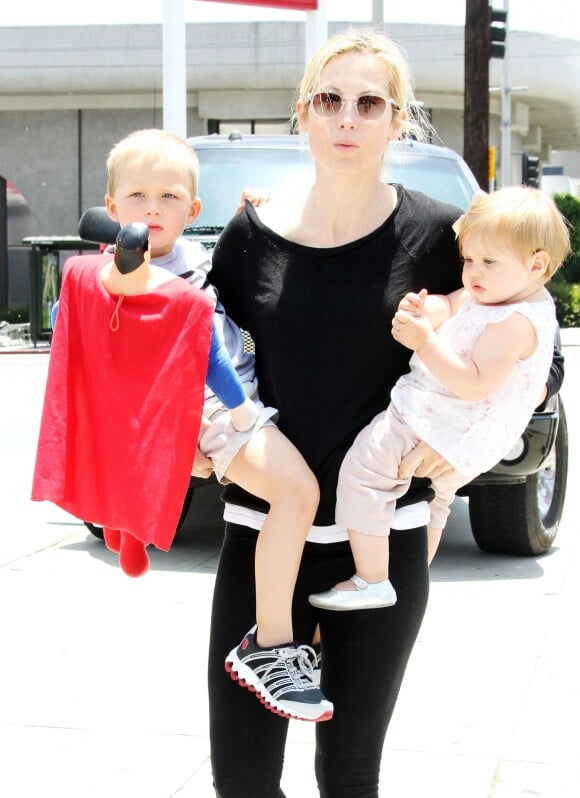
463 0 490 191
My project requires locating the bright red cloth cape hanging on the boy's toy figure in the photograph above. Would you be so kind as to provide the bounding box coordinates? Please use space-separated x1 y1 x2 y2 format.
32 255 214 551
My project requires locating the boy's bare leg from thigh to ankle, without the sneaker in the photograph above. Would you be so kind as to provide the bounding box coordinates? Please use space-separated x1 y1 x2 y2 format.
226 426 319 646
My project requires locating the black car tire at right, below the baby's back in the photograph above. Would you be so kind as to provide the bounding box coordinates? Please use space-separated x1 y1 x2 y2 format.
469 401 568 557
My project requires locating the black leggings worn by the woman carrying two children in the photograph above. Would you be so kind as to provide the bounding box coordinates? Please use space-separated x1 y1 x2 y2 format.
209 524 429 798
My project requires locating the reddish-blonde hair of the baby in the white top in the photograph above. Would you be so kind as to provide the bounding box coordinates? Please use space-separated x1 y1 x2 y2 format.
454 186 570 282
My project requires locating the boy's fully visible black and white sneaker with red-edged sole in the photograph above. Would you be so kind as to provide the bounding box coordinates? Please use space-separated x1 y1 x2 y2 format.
226 626 334 721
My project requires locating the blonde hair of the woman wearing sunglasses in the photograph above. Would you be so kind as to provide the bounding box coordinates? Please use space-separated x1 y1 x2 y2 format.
294 28 431 140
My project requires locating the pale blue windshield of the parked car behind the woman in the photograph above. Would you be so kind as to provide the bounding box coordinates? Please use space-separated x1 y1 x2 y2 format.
187 146 475 231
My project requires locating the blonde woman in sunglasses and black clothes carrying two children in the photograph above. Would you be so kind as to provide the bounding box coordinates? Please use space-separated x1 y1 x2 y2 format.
204 31 560 798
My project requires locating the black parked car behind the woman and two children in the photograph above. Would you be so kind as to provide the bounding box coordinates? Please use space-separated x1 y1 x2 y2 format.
81 132 568 555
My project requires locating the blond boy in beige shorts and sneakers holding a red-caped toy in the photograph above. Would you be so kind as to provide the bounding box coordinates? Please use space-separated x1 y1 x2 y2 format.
36 130 333 721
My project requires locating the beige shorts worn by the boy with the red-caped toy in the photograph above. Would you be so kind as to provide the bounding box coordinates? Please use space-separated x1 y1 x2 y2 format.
198 380 278 485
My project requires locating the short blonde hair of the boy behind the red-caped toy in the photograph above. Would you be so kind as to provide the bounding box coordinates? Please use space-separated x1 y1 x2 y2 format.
107 128 199 198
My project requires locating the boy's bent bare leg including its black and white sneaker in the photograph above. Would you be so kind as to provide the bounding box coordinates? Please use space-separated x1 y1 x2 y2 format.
218 426 333 721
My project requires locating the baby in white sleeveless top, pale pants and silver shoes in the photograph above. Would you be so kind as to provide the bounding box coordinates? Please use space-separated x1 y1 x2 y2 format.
309 187 570 610
